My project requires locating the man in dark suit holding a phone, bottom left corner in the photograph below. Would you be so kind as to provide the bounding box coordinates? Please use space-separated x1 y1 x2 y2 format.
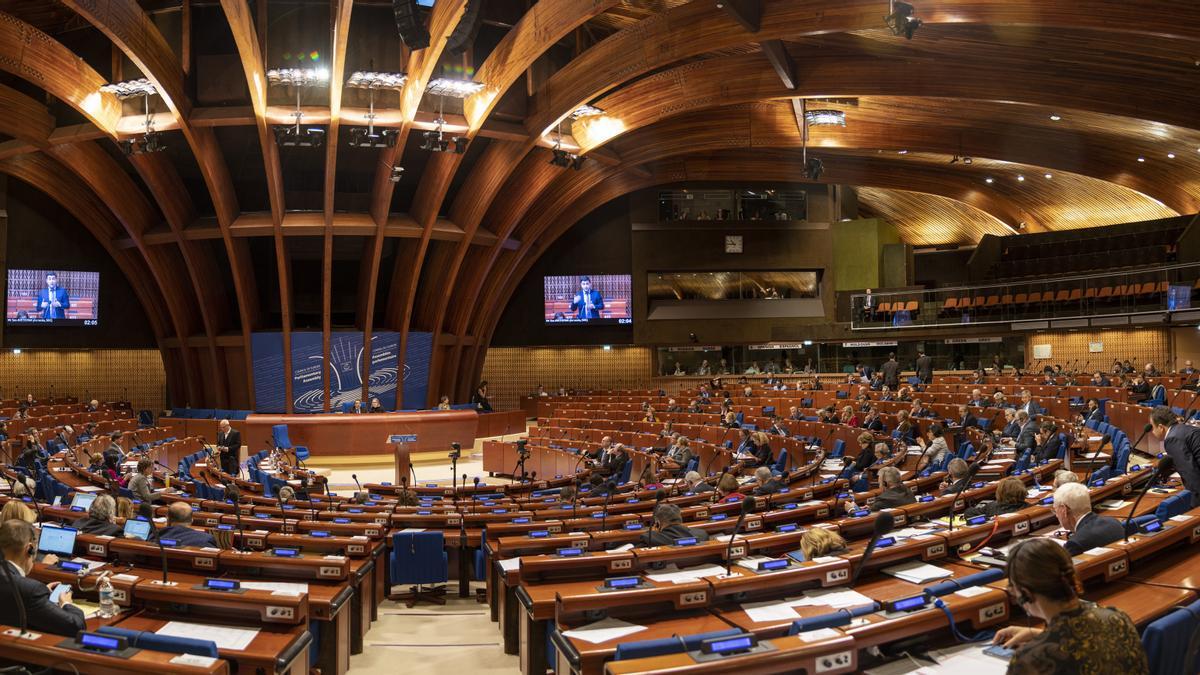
0 519 86 638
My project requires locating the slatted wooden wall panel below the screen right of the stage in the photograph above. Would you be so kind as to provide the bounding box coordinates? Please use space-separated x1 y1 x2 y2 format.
482 346 653 410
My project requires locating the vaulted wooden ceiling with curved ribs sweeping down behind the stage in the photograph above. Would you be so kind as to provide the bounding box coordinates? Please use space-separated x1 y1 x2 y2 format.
0 0 1200 407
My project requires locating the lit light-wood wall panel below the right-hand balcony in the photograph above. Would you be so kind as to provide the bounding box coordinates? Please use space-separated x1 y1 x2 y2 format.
1025 328 1171 372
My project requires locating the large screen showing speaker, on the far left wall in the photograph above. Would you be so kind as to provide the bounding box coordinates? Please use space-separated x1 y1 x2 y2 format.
5 269 100 325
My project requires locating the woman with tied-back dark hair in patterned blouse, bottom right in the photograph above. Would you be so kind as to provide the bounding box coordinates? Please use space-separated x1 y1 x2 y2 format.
995 538 1148 675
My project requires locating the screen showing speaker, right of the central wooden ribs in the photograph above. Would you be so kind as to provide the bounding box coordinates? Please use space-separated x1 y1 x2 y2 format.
544 274 634 324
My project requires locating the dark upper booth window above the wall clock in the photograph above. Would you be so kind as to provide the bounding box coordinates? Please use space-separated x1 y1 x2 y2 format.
659 189 808 222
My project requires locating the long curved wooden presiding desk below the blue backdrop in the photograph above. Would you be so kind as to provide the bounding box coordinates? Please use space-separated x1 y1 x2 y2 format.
241 403 479 458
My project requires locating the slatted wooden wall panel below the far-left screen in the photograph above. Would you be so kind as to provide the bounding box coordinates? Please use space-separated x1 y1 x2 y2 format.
0 350 167 414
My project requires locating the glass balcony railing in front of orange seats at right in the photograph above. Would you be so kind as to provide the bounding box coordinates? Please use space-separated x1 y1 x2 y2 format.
851 263 1200 330
